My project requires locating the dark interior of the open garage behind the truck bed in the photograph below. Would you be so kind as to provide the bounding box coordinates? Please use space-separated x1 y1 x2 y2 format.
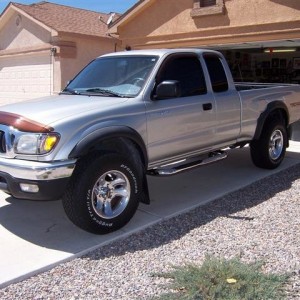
210 39 300 84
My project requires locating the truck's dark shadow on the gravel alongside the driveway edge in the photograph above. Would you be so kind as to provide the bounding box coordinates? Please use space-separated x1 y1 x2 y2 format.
85 164 300 260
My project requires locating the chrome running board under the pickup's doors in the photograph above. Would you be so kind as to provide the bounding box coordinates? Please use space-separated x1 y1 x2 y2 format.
147 151 227 176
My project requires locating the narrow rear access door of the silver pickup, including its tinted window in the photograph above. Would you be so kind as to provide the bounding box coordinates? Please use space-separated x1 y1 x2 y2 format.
203 52 241 145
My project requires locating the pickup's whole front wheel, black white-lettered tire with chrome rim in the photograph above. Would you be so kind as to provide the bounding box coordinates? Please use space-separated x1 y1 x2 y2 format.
62 153 142 234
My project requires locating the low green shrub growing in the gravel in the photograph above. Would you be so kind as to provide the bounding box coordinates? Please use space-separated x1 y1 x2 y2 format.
156 257 288 300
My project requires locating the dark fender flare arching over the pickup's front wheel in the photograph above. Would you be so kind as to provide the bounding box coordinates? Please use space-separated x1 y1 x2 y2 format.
69 126 148 166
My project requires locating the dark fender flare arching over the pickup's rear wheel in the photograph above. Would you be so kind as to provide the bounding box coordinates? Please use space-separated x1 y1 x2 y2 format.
253 101 289 140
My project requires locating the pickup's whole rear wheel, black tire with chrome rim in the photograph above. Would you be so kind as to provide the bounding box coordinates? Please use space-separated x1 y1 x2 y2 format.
250 119 287 169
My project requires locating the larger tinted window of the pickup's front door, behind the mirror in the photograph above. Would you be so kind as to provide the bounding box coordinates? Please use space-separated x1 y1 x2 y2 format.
156 55 206 97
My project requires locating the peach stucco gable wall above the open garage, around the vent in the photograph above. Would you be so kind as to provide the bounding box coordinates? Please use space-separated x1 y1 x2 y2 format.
113 0 300 48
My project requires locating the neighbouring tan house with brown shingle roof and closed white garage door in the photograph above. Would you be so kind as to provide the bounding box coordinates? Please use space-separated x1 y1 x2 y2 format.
0 1 118 104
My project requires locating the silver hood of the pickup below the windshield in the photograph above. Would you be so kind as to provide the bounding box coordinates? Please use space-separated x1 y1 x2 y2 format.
0 95 128 125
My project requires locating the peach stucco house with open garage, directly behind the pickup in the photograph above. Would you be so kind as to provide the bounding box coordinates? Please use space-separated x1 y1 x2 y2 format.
109 0 300 83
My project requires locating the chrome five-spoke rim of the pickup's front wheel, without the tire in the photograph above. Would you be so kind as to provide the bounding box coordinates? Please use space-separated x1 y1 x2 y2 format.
92 170 131 219
